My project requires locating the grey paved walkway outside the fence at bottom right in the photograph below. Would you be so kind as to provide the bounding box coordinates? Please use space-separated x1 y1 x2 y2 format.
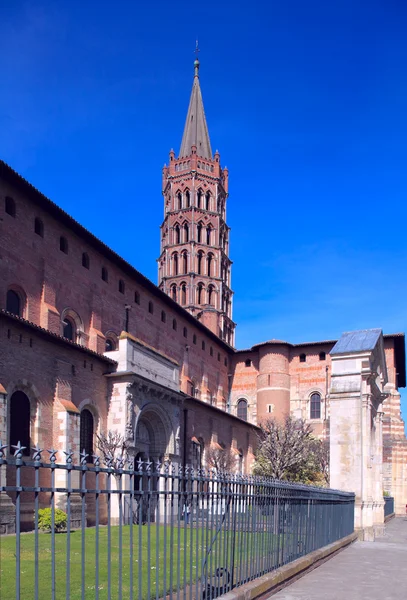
270 518 407 600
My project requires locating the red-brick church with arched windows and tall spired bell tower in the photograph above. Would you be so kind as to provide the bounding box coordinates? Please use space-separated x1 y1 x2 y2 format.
0 54 407 533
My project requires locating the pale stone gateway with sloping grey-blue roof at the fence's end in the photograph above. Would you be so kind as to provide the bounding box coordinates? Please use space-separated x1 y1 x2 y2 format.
330 329 387 540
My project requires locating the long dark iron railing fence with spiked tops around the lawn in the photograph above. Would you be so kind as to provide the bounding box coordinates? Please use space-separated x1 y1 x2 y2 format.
0 444 354 600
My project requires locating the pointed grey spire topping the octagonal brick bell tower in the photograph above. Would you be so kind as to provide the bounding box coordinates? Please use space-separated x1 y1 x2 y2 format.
179 48 212 160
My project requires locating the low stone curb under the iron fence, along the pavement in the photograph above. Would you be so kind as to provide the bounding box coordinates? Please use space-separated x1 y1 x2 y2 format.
220 532 358 600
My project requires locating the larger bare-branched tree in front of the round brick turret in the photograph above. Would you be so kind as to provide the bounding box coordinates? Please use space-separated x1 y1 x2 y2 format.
254 415 312 481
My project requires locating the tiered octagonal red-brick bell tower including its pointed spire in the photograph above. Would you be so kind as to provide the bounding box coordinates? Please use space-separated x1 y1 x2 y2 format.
158 57 236 345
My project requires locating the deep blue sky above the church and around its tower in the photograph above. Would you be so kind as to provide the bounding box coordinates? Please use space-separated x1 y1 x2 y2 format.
0 0 407 414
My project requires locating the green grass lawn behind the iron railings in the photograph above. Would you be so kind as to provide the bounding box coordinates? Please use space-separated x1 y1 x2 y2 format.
0 525 292 600
